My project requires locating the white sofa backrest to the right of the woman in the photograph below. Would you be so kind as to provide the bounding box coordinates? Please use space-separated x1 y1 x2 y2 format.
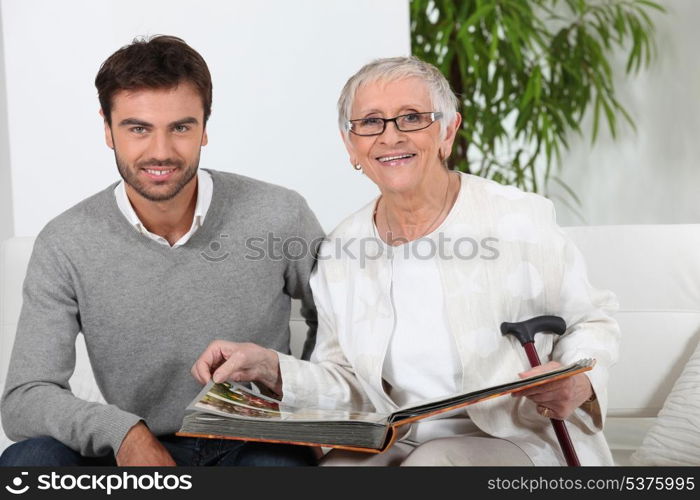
565 224 700 417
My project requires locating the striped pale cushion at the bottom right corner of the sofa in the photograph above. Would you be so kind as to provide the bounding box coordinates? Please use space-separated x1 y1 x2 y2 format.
631 343 700 466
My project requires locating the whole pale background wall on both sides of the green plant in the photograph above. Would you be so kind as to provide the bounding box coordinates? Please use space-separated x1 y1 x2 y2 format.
5 0 700 231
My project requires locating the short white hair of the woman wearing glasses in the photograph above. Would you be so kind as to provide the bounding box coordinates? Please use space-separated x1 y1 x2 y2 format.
338 57 459 138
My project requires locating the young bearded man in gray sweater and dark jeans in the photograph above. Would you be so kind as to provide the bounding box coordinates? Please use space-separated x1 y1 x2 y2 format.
0 36 323 466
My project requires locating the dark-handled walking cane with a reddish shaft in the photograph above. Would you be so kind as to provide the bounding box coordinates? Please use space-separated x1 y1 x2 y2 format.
501 316 581 467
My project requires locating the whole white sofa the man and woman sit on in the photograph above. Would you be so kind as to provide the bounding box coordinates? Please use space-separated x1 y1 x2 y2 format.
0 224 700 465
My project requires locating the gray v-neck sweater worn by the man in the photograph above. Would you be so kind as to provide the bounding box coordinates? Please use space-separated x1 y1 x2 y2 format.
0 171 323 456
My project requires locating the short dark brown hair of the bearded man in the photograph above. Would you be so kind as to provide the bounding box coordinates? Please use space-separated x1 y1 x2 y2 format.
95 35 212 125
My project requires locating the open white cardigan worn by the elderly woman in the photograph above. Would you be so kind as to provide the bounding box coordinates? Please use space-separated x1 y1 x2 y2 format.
280 174 619 465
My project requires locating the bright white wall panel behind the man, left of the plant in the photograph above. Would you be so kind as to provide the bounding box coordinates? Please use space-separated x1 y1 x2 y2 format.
0 0 410 236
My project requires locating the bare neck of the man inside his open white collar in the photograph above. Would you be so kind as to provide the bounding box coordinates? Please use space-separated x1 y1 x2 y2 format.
125 176 198 245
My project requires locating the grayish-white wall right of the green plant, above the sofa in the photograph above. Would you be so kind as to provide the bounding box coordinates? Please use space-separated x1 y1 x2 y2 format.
557 0 700 224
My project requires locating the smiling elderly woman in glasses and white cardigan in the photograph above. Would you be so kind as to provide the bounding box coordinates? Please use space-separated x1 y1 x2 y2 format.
192 58 619 465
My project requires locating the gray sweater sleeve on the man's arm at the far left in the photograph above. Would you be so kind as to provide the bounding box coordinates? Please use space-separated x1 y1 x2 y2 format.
0 233 140 456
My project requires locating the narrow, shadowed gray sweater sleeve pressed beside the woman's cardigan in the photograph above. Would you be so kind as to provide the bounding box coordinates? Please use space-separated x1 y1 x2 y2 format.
285 196 325 359
